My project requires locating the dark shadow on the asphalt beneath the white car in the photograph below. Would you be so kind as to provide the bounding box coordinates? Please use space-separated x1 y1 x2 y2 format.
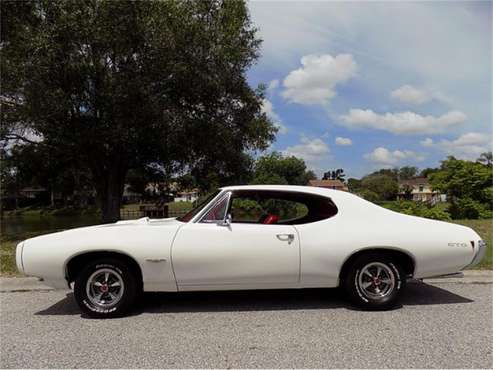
36 282 473 315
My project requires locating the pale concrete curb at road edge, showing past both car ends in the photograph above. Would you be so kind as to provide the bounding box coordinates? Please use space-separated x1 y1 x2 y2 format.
0 270 493 293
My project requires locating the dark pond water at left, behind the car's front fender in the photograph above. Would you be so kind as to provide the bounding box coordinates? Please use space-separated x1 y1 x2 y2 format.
1 215 101 240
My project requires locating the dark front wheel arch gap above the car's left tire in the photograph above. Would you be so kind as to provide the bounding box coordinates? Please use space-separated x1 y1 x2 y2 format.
64 250 143 285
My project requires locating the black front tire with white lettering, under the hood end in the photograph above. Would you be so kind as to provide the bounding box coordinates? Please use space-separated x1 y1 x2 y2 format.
74 258 141 318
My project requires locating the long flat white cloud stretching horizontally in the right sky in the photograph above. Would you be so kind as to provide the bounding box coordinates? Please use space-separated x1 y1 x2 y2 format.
341 109 467 135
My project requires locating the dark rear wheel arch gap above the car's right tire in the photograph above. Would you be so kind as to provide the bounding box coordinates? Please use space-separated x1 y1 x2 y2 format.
338 246 416 285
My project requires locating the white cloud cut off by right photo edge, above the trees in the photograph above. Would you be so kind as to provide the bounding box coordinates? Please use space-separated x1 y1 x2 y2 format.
420 132 493 160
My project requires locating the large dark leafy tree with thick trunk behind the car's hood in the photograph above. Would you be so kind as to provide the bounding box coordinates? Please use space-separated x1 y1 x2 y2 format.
1 0 276 222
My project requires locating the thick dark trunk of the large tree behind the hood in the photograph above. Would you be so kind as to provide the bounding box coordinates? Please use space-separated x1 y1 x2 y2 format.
94 161 127 223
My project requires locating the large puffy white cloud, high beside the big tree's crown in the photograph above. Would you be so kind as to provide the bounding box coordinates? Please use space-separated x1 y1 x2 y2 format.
282 54 356 105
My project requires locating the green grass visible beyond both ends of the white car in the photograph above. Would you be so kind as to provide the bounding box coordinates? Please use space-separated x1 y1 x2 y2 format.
0 218 493 276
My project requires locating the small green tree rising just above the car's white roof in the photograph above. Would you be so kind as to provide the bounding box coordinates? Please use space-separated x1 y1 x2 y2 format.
251 152 316 185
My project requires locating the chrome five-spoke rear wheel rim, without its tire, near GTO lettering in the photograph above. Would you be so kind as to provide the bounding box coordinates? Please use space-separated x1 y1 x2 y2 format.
358 262 396 299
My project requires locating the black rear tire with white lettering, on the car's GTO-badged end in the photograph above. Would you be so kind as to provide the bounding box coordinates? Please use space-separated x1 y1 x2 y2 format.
343 253 406 310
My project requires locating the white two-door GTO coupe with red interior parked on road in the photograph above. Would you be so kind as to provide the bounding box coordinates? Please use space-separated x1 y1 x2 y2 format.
16 185 486 317
